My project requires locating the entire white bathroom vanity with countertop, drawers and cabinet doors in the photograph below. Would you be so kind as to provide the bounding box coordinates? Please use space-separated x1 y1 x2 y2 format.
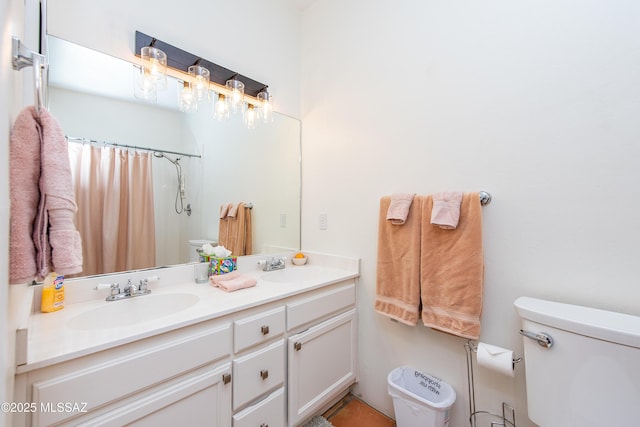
14 255 359 427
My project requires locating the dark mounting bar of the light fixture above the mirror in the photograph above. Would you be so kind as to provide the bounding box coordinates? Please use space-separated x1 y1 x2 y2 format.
135 31 267 98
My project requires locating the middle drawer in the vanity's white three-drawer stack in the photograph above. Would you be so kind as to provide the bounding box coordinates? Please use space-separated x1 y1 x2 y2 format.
232 340 285 411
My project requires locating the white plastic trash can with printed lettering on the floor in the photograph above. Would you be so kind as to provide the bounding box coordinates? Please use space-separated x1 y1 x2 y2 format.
387 366 456 427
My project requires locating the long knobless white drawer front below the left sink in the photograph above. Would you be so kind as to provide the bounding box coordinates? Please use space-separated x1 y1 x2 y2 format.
32 324 231 426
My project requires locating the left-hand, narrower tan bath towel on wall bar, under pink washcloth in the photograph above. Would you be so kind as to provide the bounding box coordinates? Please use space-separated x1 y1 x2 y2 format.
374 196 422 325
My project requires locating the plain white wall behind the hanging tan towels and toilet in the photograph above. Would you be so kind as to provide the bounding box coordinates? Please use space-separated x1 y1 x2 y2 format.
301 0 640 426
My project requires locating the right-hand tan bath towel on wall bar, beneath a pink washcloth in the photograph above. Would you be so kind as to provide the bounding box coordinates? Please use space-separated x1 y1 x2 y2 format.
420 193 484 339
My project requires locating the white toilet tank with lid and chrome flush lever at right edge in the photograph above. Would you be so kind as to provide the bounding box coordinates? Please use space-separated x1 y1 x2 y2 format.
514 297 640 427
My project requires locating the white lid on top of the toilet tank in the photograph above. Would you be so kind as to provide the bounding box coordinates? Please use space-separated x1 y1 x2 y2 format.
514 297 640 348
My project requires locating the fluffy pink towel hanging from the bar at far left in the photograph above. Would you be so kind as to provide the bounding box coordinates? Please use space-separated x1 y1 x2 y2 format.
9 107 82 283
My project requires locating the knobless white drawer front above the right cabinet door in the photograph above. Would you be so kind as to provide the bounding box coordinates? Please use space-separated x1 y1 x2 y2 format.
287 283 356 331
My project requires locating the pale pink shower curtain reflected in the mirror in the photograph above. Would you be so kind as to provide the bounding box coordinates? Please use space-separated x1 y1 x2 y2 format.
69 144 156 275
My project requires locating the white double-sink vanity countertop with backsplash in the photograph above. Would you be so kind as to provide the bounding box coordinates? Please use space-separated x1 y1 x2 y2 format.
17 254 359 373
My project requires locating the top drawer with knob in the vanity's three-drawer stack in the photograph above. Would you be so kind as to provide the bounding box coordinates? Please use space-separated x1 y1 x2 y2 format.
233 307 285 353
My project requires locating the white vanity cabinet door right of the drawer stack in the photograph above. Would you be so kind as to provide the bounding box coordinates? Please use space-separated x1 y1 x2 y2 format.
288 309 357 426
